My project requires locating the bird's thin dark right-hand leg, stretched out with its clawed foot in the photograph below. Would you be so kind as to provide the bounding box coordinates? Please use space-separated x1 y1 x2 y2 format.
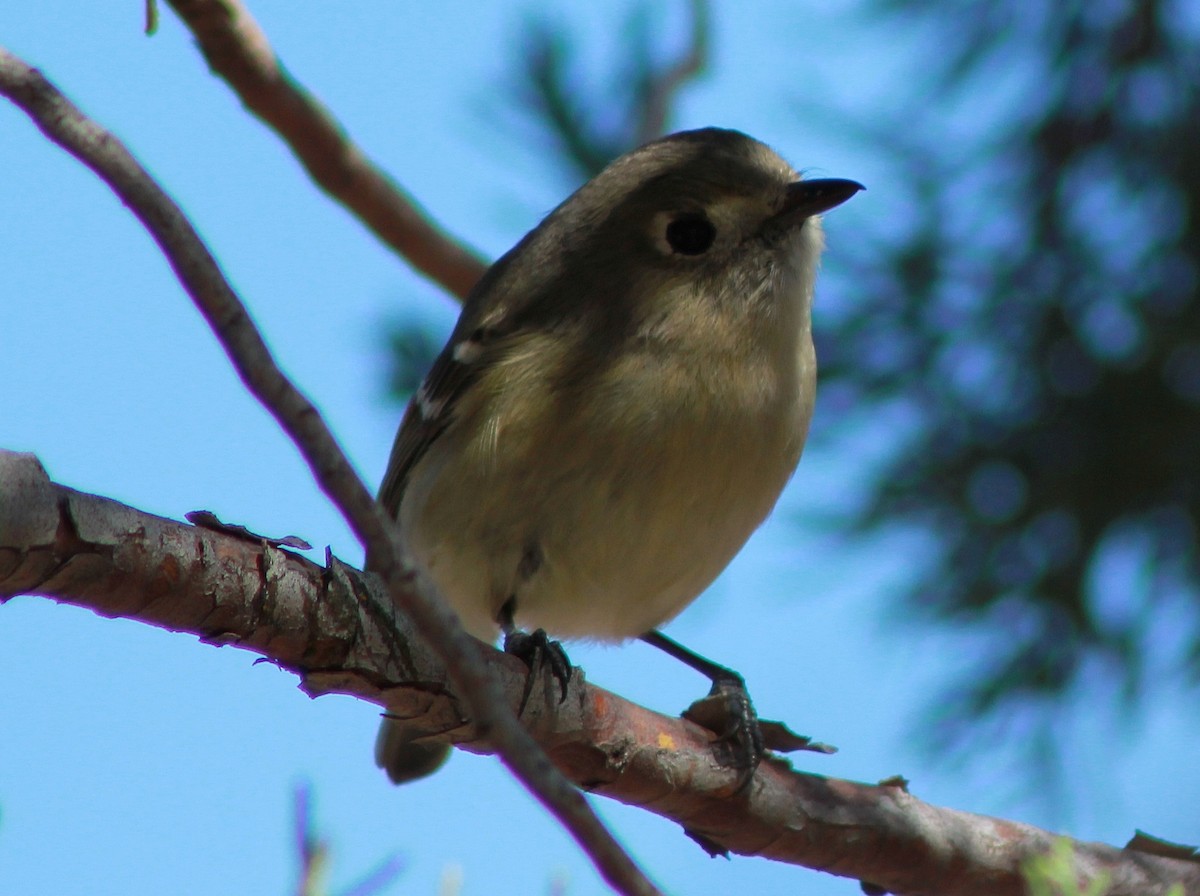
641 631 766 789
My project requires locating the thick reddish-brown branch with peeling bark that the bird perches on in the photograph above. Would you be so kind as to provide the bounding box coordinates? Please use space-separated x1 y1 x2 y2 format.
0 452 1200 896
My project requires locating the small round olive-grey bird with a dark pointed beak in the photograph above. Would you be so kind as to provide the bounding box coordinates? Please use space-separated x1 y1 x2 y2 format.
376 128 863 783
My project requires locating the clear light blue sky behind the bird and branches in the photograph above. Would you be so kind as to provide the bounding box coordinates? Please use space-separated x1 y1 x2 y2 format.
0 0 1200 896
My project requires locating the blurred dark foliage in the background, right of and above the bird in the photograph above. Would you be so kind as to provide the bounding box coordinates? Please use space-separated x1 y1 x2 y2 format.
388 0 1200 746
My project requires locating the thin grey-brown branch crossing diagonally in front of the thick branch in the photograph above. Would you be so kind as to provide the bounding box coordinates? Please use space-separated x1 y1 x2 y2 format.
0 48 658 894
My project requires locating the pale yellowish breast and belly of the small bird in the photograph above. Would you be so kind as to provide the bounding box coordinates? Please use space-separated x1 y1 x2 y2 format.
401 289 815 639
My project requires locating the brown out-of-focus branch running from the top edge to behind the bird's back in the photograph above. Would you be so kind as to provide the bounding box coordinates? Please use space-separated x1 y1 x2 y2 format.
168 0 487 300
